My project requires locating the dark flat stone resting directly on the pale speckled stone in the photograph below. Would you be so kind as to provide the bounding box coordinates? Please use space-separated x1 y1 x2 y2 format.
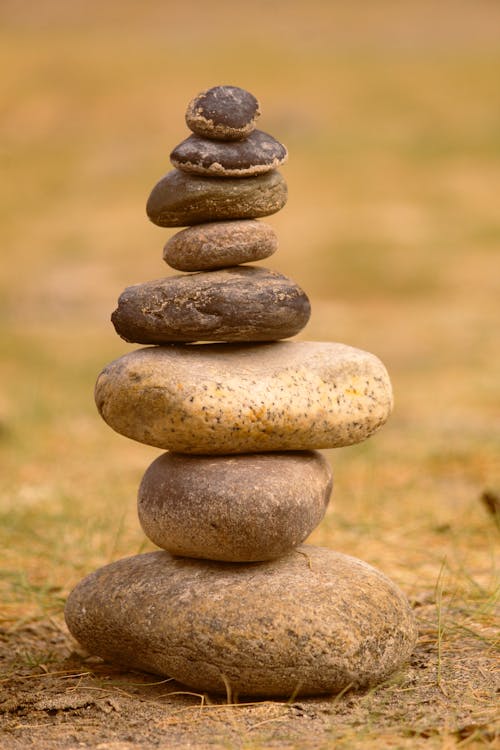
111 266 311 344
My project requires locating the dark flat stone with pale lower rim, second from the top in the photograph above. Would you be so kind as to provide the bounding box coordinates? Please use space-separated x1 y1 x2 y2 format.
170 130 288 177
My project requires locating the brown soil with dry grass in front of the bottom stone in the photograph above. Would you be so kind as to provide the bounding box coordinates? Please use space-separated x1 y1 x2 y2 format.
0 604 498 750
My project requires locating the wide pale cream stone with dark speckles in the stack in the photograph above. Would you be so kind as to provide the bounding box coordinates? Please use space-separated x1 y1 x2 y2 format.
95 341 392 455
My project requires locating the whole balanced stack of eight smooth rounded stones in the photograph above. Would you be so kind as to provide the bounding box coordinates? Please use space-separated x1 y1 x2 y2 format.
66 86 416 697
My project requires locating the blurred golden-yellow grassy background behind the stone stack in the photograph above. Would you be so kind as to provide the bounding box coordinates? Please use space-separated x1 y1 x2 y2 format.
0 0 500 617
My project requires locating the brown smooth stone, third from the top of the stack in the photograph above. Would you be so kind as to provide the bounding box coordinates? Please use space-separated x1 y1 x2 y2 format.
146 169 287 227
